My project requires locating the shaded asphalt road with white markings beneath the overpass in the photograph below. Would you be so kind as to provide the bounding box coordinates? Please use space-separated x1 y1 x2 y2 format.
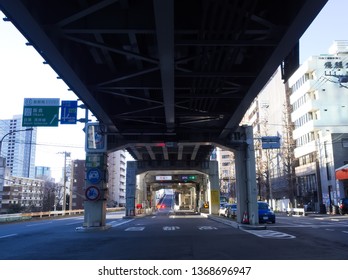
0 209 348 260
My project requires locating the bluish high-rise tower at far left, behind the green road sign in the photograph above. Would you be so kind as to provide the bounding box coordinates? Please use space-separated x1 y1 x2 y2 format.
0 115 37 178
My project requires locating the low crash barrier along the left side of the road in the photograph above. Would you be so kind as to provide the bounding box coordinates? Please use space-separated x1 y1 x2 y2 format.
0 207 124 222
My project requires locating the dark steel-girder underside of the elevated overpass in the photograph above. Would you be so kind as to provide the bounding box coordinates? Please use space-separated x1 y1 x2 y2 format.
0 0 327 228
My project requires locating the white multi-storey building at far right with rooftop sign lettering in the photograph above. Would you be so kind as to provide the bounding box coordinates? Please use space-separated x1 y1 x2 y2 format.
288 41 348 210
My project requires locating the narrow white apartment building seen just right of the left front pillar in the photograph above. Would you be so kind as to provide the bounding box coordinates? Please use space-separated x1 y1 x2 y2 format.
107 150 126 207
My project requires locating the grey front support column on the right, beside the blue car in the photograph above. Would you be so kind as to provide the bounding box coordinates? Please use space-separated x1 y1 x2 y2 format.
234 126 259 225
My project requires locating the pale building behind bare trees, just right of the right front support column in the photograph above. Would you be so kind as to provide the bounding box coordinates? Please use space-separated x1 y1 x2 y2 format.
242 67 294 209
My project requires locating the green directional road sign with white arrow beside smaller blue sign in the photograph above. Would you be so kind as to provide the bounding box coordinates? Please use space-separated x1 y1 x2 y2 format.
22 98 60 127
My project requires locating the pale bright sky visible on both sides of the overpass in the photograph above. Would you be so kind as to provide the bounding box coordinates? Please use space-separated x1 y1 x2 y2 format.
0 0 348 179
